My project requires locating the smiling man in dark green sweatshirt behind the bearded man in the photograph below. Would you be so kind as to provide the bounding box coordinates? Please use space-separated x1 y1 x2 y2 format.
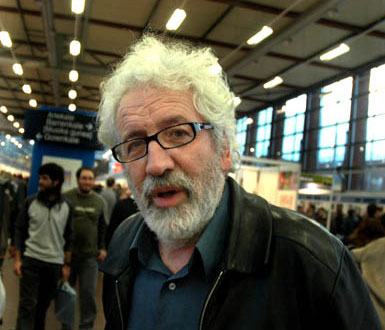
64 167 106 329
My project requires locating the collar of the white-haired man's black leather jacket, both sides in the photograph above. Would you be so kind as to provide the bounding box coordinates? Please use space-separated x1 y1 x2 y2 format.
100 178 273 276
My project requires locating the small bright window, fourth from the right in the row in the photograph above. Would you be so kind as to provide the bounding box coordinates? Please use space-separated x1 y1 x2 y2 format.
255 107 273 157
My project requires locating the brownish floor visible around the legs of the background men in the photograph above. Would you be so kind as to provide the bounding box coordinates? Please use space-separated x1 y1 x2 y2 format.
0 257 105 330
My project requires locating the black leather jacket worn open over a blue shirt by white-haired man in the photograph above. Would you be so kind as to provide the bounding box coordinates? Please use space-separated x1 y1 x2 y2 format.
101 179 381 330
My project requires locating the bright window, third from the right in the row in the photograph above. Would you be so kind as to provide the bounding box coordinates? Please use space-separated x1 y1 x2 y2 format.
282 94 307 162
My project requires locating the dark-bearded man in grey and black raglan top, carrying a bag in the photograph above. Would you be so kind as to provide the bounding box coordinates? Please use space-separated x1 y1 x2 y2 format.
14 163 72 330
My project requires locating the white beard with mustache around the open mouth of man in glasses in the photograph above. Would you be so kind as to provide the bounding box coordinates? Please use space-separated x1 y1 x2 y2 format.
128 155 225 248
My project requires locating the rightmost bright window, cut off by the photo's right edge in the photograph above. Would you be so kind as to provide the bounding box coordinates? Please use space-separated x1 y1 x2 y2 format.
365 64 385 162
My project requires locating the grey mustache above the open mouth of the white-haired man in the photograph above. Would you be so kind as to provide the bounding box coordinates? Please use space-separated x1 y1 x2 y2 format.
141 172 194 200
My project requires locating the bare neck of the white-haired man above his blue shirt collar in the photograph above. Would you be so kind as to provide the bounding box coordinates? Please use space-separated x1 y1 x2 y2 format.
158 242 196 274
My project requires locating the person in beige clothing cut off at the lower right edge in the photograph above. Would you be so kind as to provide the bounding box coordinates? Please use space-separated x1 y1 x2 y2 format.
351 215 385 329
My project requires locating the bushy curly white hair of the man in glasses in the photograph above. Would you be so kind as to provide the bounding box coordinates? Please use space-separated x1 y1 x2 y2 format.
98 35 240 170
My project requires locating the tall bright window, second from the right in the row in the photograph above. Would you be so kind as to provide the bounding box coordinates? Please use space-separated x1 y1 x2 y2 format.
318 77 353 168
